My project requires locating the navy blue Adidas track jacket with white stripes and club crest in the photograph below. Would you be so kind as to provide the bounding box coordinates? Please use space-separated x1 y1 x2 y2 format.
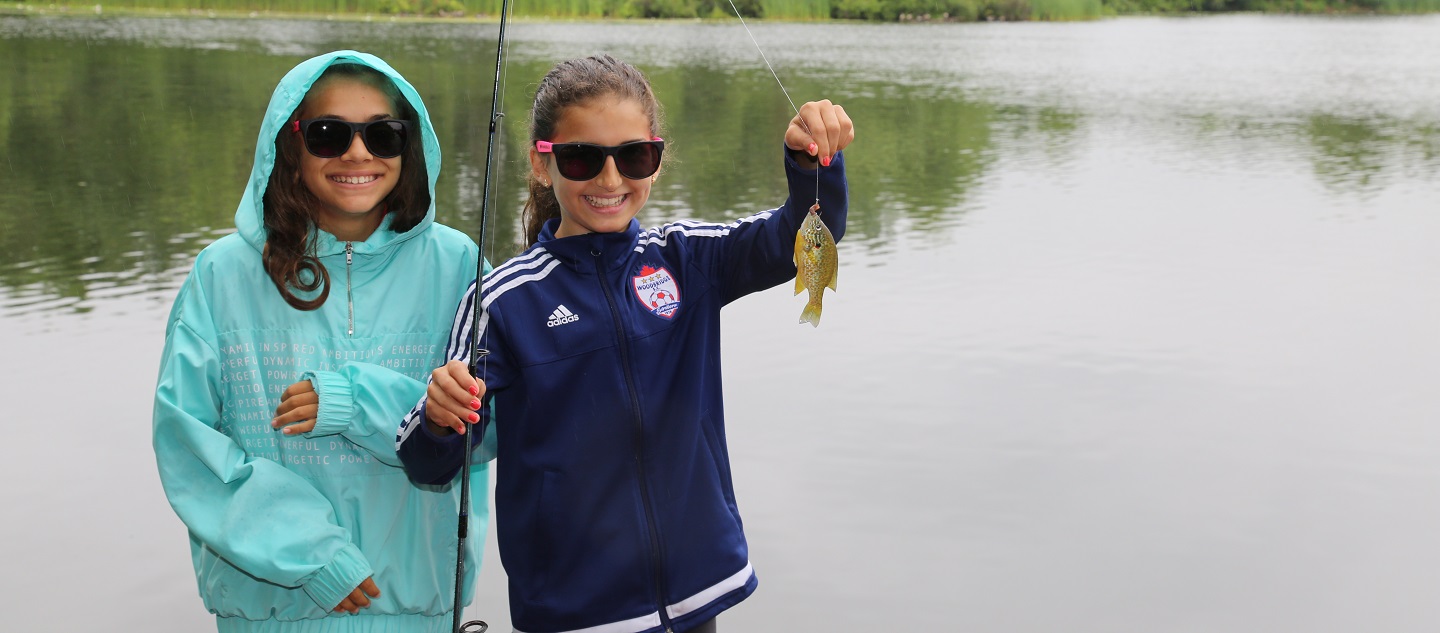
396 149 848 633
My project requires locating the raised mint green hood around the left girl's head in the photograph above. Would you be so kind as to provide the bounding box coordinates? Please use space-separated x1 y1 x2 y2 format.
235 50 441 256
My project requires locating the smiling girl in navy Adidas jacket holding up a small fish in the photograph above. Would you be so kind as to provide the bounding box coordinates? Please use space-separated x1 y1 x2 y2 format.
397 56 854 633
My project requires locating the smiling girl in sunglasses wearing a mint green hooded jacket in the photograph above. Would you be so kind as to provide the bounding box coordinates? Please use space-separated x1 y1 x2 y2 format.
154 50 488 632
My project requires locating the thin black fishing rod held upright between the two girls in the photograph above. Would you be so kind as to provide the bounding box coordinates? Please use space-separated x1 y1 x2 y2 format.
452 0 510 633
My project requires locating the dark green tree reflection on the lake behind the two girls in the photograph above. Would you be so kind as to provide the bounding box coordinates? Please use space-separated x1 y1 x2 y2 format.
0 17 1013 312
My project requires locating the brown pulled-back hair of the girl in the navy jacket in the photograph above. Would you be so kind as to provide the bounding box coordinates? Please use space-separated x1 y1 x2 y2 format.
521 55 664 246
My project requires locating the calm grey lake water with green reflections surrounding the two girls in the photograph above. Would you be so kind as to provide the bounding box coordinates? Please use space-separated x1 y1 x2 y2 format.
0 16 1440 633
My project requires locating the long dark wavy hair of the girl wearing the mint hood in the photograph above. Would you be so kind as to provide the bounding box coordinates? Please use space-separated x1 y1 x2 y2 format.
264 63 431 311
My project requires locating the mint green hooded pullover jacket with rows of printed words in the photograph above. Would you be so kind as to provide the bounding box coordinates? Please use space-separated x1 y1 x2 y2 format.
154 50 492 632
